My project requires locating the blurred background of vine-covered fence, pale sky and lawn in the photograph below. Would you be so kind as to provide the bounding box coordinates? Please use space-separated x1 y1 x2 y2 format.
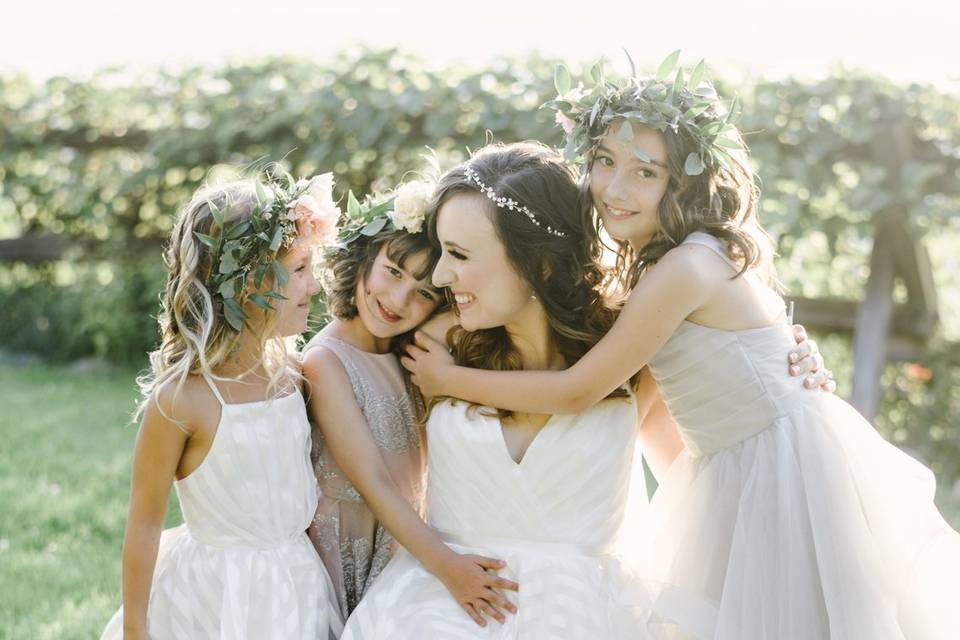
0 0 960 639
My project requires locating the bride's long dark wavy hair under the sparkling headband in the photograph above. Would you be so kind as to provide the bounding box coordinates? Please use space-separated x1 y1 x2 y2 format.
426 142 626 418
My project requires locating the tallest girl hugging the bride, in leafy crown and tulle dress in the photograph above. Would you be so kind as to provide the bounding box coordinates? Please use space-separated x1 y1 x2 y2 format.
406 57 960 640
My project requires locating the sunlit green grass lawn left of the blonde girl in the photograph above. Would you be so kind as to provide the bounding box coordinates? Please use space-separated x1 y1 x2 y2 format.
0 363 960 640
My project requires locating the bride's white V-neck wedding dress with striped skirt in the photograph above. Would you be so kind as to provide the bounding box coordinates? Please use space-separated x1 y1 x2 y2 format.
342 398 646 640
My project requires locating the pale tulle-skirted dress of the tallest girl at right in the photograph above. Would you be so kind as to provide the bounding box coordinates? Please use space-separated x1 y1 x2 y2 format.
637 232 960 640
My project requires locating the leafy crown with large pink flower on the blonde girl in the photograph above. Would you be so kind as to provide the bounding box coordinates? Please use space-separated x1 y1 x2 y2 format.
193 173 341 331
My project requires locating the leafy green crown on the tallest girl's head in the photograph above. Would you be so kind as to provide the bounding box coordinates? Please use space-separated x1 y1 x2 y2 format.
543 49 743 176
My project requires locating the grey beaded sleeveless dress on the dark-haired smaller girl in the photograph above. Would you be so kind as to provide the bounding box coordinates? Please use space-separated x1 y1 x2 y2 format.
303 332 424 618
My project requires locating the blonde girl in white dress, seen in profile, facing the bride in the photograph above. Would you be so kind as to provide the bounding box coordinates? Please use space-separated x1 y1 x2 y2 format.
103 174 342 640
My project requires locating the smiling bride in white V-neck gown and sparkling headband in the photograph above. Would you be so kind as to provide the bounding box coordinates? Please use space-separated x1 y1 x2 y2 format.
343 143 828 640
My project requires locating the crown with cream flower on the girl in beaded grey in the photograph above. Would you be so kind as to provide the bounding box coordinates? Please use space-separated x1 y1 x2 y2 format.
330 180 436 251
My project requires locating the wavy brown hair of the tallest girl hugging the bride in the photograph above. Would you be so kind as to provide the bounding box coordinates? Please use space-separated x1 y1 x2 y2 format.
581 119 775 291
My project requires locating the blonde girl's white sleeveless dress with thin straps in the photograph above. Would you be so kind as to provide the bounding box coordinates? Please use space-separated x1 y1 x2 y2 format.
102 380 343 640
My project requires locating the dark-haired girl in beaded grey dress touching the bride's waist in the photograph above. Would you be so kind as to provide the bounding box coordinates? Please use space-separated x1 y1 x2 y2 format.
303 182 517 626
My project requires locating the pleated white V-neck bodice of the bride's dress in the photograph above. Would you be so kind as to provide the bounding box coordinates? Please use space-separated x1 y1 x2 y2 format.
427 398 636 546
